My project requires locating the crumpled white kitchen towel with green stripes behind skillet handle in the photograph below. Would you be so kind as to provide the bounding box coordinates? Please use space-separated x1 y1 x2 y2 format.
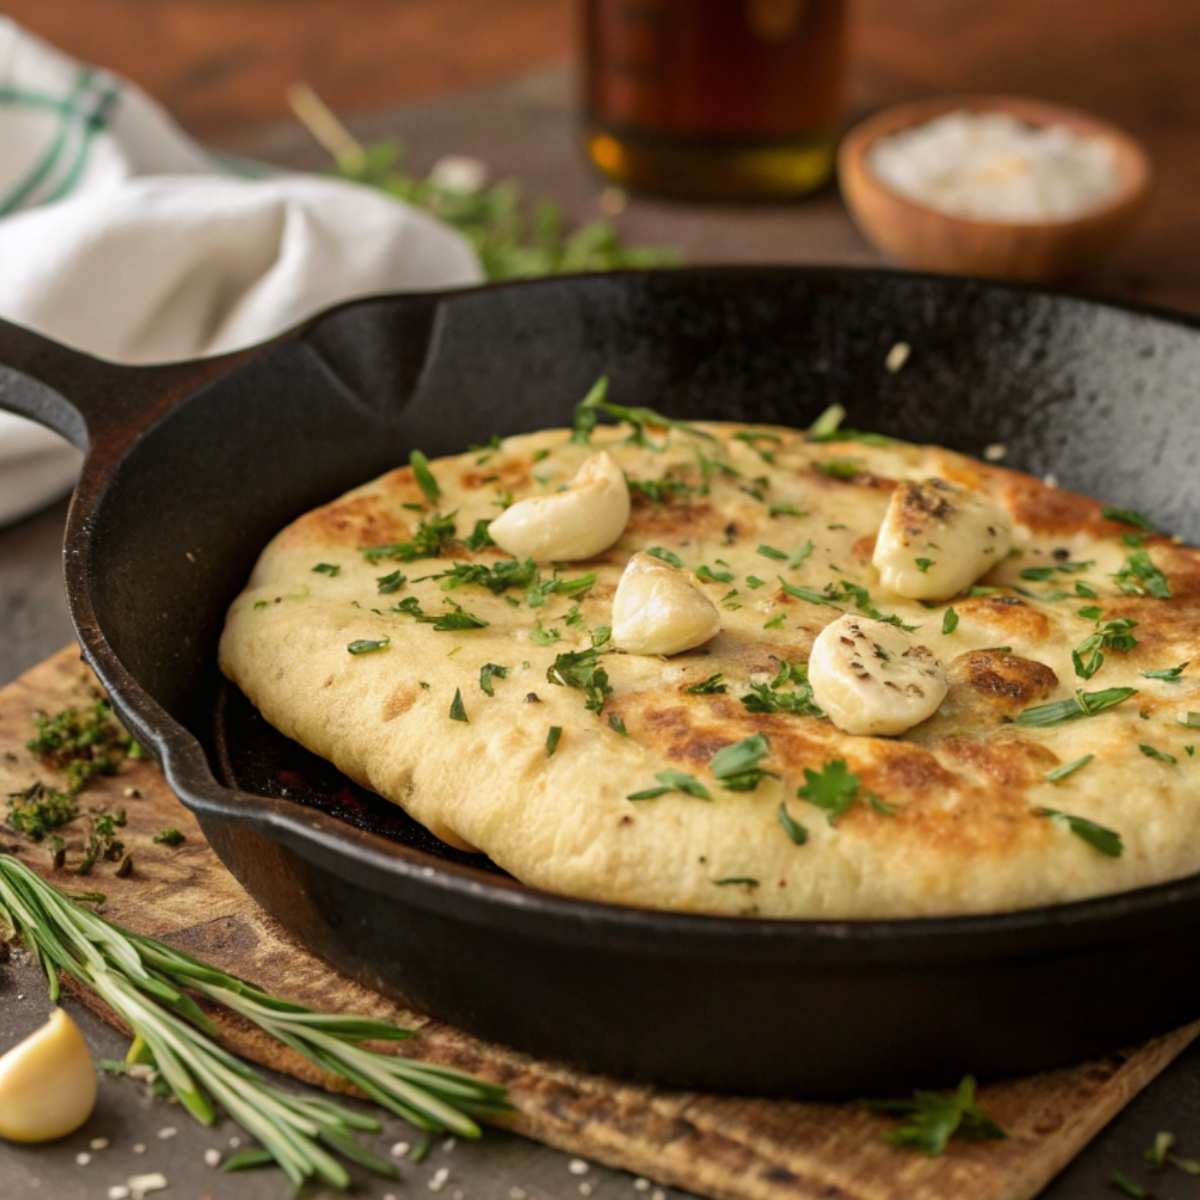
0 17 482 524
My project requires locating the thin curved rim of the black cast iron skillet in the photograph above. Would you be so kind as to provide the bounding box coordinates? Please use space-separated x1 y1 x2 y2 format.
64 264 1200 965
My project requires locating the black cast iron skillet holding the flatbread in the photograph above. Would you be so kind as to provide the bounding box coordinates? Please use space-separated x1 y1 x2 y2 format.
0 269 1200 1094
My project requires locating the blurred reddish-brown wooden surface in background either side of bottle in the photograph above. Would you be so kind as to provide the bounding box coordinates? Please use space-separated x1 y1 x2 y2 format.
5 0 1200 310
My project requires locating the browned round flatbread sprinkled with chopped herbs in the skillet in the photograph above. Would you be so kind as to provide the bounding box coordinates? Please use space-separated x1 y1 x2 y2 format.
221 424 1200 918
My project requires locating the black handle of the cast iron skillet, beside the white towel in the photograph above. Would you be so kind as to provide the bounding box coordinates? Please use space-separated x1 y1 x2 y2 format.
0 320 262 458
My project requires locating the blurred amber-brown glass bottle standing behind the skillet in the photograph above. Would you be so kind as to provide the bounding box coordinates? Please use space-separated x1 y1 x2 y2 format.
581 0 846 200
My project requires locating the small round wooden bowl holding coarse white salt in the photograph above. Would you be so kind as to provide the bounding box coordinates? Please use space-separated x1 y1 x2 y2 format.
838 96 1151 282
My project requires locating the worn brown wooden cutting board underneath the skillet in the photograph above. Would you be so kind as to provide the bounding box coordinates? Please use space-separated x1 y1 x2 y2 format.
0 647 1200 1200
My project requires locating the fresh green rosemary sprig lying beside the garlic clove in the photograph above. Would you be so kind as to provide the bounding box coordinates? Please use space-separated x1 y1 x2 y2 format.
0 854 506 1188
